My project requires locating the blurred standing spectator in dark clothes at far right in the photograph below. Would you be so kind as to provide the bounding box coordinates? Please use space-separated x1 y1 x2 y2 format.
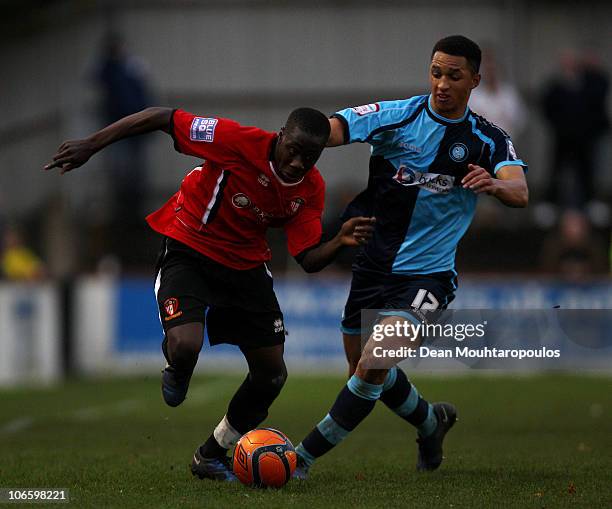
542 50 610 210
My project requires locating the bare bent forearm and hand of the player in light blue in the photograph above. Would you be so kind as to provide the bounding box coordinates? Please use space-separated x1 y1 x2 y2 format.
461 164 529 207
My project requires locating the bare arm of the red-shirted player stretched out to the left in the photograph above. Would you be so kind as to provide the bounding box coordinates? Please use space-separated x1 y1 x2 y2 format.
43 108 172 174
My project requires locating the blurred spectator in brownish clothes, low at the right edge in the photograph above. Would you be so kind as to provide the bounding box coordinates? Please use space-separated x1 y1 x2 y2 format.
541 209 608 281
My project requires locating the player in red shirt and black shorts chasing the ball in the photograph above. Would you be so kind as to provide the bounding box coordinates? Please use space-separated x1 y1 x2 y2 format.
45 108 374 481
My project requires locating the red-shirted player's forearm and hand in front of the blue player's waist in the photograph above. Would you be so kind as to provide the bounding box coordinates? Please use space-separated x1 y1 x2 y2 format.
296 217 376 273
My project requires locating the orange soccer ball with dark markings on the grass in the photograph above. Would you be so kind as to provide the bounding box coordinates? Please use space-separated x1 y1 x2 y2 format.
234 428 297 488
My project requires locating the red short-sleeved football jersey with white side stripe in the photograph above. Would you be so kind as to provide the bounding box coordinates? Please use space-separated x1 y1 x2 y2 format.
147 110 325 269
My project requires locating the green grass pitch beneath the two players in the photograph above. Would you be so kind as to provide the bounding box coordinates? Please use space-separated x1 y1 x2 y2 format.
0 374 612 509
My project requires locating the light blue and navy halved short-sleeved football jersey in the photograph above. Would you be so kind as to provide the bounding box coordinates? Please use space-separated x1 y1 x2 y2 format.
334 95 527 274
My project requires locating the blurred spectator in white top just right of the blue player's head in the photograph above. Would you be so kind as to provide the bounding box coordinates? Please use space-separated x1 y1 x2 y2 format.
469 47 526 138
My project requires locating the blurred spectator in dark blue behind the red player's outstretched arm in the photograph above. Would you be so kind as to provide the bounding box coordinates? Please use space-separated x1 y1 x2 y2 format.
94 32 152 266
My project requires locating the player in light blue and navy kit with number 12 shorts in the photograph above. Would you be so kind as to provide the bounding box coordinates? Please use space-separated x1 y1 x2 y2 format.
294 35 528 479
